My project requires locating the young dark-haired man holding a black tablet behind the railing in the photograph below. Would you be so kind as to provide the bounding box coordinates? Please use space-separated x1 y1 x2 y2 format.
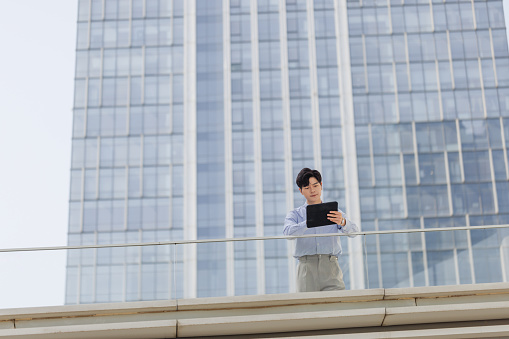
283 168 359 292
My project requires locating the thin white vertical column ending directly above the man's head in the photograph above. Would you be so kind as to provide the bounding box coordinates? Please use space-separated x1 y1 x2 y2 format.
306 0 322 172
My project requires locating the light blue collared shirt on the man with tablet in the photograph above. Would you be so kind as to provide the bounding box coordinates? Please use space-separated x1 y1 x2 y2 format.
283 203 359 258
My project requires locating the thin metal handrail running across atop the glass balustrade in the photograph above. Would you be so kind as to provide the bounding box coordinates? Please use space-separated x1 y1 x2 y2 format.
0 224 509 253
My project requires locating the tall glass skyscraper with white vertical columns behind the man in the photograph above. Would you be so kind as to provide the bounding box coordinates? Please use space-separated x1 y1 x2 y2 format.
66 0 509 304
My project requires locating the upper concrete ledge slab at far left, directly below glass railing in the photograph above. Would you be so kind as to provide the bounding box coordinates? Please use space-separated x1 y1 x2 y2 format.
0 300 177 321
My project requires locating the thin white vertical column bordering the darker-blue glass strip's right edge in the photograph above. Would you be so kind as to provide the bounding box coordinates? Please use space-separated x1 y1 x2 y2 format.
223 0 235 296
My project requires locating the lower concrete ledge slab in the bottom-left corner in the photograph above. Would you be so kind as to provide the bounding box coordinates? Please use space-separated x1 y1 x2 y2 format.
0 320 177 339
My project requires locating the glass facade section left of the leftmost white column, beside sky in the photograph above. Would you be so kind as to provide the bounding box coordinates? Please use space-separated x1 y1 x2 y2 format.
66 0 184 304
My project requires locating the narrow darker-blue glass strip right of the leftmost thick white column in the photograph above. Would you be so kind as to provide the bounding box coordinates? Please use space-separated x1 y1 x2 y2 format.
196 0 226 297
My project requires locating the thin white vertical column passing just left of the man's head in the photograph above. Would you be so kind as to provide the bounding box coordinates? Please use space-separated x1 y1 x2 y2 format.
279 0 296 291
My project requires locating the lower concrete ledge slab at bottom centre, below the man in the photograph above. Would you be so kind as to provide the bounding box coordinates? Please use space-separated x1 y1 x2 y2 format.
178 308 385 337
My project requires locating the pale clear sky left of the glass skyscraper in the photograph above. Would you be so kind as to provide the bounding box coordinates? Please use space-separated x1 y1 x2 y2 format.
0 0 509 309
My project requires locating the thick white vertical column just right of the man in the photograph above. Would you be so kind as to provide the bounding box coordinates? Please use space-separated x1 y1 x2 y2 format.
334 0 365 289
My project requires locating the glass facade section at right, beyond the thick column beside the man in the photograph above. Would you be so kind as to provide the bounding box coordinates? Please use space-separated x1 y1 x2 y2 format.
348 1 509 287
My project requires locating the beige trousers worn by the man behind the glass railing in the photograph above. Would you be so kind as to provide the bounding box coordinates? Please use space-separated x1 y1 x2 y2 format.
297 254 345 292
